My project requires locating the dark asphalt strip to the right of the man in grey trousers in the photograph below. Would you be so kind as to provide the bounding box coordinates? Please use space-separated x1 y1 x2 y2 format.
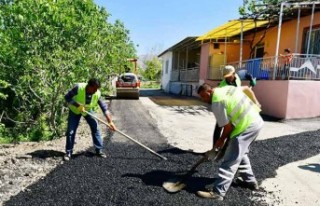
249 130 320 180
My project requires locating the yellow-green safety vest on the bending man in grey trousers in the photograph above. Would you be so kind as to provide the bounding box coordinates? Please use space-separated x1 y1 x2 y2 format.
212 86 261 138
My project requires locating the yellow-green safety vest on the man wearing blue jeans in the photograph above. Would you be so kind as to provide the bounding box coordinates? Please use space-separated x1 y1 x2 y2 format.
69 83 101 116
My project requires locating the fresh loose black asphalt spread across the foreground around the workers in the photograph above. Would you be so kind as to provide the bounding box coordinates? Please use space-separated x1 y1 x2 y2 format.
4 130 320 206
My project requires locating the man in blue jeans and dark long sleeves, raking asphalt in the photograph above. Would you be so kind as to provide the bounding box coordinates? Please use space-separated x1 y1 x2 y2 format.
64 78 116 161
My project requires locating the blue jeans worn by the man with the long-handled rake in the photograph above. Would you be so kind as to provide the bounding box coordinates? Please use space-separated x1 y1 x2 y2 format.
66 110 103 154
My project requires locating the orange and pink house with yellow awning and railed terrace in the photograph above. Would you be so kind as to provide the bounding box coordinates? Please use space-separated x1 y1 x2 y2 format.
197 2 320 119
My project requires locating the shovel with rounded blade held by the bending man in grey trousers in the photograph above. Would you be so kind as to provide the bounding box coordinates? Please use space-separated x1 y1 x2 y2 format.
162 142 227 193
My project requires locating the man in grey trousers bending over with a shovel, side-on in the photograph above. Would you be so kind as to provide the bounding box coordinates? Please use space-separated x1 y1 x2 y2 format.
197 84 263 200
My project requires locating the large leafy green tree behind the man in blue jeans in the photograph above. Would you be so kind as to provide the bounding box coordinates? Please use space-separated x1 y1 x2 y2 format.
0 0 135 140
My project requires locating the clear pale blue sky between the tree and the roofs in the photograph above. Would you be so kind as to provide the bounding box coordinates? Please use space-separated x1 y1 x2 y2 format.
94 0 243 56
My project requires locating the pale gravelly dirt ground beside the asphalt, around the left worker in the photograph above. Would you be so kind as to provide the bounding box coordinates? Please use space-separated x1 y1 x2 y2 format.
0 121 99 205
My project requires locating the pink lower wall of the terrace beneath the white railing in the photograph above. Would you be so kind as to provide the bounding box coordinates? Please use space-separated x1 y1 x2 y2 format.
199 80 320 119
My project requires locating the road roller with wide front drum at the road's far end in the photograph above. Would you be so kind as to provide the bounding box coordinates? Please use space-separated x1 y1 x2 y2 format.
116 73 140 99
